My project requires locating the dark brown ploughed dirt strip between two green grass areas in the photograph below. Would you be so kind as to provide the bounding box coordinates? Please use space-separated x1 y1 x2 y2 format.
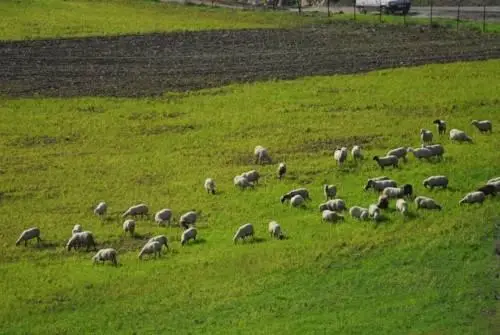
0 22 500 96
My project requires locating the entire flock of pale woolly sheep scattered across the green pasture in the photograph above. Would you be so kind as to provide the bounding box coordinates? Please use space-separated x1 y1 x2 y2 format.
16 120 500 265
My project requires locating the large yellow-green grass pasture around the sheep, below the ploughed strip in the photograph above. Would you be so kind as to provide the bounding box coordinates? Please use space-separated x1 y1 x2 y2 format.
0 61 500 335
